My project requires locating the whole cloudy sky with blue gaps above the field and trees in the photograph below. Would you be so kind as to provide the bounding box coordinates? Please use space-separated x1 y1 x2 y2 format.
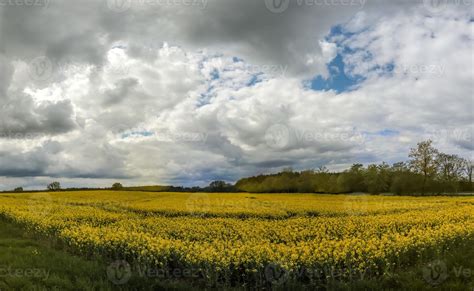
0 0 474 190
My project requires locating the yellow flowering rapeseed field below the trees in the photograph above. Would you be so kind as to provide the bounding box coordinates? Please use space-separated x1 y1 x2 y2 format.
0 191 474 288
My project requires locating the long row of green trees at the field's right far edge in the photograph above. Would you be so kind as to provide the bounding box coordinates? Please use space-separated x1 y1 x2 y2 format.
235 140 473 194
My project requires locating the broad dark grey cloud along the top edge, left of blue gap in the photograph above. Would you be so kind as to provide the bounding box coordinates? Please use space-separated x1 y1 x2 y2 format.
0 0 386 75
